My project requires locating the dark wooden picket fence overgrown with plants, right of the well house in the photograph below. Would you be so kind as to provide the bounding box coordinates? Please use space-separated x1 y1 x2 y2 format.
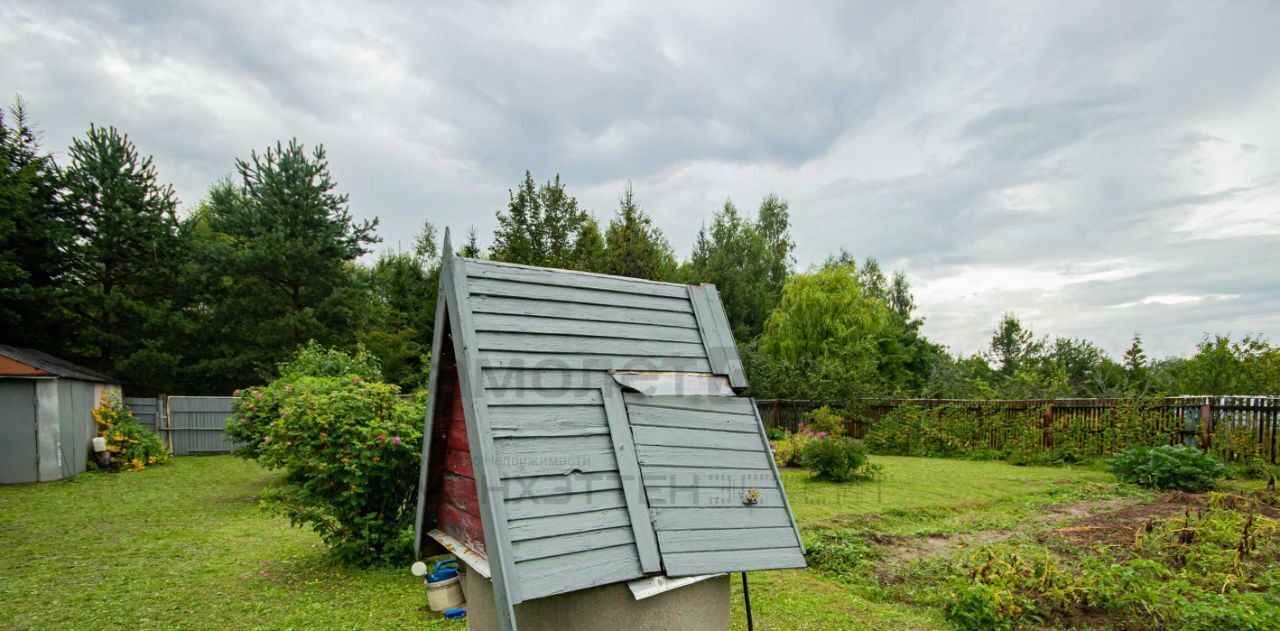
755 395 1280 463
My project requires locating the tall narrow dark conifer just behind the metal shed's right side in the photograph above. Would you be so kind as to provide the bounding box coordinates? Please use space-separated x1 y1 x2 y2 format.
60 125 184 390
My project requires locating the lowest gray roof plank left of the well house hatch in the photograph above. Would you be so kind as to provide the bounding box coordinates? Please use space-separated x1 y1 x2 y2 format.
516 545 644 598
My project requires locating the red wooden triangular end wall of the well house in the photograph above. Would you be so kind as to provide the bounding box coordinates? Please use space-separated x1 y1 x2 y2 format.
426 337 485 555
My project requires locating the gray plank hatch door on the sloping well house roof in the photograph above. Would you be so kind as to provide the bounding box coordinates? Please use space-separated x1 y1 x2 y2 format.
623 393 805 576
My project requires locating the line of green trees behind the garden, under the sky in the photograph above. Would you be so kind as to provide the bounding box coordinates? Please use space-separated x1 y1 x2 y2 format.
0 99 1280 401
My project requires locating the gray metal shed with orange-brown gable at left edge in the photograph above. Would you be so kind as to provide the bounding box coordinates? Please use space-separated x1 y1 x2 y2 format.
0 344 119 484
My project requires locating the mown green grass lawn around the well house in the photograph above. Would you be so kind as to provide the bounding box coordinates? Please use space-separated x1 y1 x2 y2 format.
0 456 1131 630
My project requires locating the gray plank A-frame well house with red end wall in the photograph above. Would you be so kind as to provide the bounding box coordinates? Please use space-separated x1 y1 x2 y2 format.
415 234 805 630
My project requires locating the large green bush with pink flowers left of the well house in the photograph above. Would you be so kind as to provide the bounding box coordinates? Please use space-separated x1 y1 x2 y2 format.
227 346 425 564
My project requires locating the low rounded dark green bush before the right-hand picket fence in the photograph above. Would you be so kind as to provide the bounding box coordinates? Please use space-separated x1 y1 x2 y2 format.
1107 445 1224 493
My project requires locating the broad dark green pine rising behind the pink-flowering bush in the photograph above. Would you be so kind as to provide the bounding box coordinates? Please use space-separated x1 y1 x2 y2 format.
197 140 380 389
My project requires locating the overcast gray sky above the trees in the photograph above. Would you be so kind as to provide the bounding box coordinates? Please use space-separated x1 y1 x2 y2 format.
0 1 1280 356
